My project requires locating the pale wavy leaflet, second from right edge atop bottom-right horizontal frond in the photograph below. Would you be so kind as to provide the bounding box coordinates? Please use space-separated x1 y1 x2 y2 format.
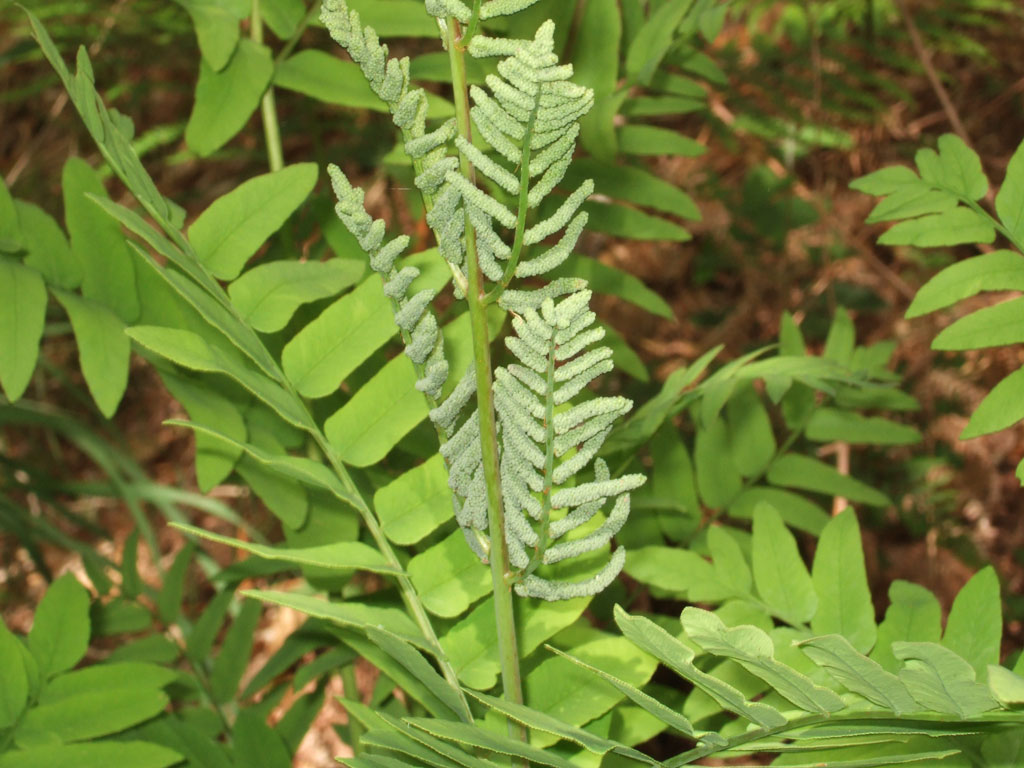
893 642 997 718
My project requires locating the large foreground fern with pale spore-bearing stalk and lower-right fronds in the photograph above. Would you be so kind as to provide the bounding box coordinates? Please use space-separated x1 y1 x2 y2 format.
14 6 1020 768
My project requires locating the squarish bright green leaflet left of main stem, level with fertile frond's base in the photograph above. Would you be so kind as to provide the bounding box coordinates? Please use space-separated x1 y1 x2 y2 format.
406 528 490 617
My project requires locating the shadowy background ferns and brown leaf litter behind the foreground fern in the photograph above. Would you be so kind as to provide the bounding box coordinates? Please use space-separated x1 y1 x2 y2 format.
0 0 1024 766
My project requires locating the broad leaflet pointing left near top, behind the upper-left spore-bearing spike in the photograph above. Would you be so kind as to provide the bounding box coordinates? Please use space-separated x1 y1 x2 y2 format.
273 49 455 120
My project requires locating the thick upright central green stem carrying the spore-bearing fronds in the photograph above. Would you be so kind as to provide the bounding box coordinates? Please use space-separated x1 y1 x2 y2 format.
447 17 526 741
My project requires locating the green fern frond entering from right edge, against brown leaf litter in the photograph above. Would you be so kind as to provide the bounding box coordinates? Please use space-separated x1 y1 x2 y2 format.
851 134 1024 483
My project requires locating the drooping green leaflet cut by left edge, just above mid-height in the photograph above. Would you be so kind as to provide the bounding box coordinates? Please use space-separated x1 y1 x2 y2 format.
0 258 46 402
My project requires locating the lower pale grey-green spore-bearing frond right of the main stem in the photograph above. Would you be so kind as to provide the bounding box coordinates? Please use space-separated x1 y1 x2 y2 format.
442 290 645 600
